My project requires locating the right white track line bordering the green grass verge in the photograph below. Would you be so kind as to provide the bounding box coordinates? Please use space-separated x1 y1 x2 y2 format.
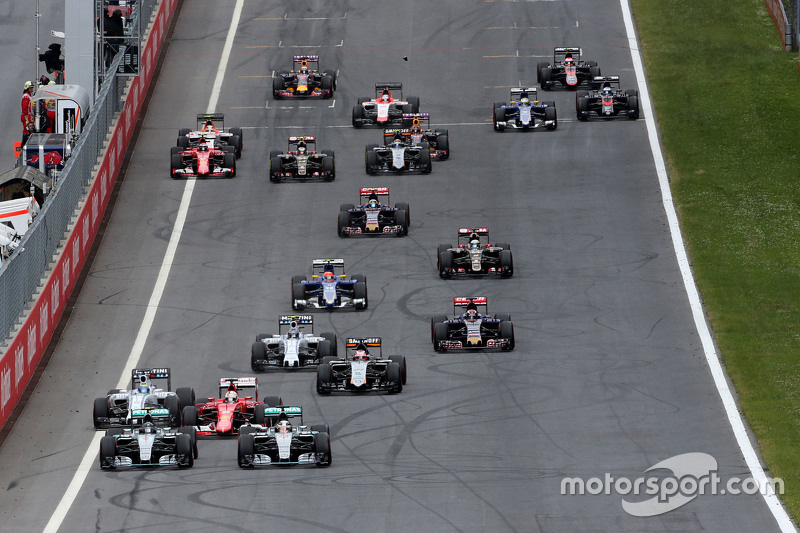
620 0 796 532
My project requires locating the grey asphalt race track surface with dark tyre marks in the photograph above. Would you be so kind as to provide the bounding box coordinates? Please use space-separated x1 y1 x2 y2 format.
0 0 788 533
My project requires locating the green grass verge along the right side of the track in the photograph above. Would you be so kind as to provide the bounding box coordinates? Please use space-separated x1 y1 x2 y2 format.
632 0 800 521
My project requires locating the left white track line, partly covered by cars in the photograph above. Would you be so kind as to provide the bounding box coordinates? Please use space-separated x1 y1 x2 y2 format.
43 0 244 533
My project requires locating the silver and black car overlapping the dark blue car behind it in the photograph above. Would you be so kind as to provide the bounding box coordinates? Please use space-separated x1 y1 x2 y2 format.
364 129 433 175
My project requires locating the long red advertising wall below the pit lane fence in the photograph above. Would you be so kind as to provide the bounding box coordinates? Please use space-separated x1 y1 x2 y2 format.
0 0 178 428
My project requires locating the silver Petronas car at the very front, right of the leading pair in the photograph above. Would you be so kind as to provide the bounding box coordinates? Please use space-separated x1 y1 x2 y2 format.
237 406 333 468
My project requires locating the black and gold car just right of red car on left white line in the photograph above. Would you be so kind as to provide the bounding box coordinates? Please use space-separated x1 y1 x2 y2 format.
269 135 336 182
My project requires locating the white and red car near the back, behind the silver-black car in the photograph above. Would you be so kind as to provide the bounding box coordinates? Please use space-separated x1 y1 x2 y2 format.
353 82 419 128
